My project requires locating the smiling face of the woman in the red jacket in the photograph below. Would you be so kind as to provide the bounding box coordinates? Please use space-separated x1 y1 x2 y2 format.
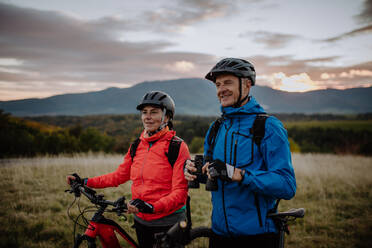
141 106 168 133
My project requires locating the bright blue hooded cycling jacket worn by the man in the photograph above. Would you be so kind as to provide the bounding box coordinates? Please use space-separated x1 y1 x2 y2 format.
204 97 296 236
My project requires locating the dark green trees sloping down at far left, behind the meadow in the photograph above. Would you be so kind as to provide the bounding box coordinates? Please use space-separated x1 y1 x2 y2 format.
0 110 115 158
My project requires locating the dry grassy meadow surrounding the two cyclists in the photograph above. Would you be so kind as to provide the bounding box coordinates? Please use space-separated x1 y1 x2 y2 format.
0 154 372 248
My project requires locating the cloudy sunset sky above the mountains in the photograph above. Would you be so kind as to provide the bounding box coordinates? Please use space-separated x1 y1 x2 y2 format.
0 0 372 101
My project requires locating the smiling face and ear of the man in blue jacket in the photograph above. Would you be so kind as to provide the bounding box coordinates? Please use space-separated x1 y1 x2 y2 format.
215 74 250 107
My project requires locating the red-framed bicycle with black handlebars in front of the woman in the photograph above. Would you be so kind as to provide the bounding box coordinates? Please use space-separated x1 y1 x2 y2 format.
65 181 213 248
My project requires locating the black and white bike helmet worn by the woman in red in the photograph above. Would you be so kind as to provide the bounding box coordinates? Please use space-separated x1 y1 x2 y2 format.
137 91 175 119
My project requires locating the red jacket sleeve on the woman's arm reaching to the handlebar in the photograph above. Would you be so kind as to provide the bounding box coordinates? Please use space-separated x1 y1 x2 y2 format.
87 150 132 188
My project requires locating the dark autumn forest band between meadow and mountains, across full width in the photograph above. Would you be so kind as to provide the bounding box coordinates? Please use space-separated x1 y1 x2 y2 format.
0 110 372 158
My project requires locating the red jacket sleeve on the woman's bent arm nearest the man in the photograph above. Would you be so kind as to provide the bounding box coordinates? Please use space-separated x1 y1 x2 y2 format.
153 142 190 213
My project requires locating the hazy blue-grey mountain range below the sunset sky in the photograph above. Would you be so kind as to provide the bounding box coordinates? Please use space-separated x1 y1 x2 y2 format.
0 78 372 116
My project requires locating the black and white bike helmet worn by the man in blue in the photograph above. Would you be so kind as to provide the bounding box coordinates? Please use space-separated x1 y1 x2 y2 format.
205 58 256 86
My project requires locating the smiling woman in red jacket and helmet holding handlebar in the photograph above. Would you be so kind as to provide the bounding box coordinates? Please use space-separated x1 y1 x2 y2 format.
67 91 190 247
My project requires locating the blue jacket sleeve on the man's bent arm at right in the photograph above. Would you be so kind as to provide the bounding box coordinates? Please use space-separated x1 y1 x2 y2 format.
243 117 296 200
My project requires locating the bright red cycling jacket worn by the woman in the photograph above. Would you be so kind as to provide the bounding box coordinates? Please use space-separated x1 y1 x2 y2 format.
87 127 190 221
